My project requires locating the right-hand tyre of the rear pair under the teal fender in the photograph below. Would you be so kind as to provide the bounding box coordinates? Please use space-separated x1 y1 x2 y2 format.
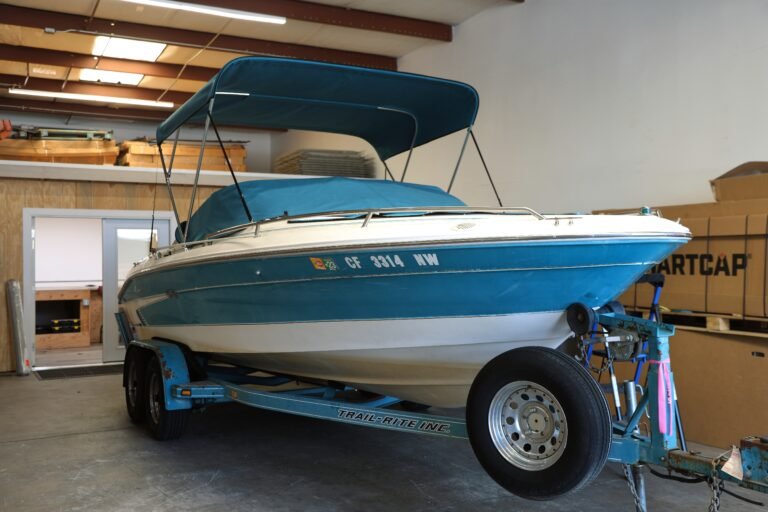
144 355 190 441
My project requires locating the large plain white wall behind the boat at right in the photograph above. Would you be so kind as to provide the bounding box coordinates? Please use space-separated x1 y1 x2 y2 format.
399 0 768 212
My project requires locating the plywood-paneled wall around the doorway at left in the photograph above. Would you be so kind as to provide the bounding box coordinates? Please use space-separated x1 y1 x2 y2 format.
0 178 220 372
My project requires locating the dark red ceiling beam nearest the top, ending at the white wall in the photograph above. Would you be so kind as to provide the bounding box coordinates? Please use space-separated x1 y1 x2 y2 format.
185 0 453 42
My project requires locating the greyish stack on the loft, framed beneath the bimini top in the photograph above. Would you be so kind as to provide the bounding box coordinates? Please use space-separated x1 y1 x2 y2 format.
273 149 376 178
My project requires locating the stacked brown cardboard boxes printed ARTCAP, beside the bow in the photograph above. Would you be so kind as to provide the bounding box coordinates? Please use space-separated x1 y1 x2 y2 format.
603 162 768 319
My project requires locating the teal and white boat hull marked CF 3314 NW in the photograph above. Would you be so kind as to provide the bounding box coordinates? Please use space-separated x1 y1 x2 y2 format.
121 233 683 407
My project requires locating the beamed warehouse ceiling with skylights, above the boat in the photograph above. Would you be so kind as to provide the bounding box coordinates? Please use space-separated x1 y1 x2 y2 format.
0 0 510 124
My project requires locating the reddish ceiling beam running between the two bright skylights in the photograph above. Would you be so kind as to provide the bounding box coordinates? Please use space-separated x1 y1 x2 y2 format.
0 44 218 82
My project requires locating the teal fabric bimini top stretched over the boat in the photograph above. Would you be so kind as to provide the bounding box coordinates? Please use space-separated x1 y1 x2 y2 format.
157 57 479 160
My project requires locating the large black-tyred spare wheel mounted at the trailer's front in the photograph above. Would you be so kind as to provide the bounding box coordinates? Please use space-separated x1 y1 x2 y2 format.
467 347 611 500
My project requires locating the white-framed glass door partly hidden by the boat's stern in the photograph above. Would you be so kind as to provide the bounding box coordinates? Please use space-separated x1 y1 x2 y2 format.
102 219 171 363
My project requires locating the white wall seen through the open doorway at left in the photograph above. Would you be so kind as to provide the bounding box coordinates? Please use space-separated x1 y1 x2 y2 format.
35 217 102 288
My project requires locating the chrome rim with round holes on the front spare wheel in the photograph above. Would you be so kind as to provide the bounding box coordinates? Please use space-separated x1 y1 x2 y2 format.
488 381 568 471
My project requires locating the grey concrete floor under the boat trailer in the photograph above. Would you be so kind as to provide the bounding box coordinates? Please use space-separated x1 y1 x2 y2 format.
0 375 760 512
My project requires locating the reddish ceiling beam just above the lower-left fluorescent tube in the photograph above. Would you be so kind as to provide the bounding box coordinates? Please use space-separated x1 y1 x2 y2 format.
0 74 192 105
